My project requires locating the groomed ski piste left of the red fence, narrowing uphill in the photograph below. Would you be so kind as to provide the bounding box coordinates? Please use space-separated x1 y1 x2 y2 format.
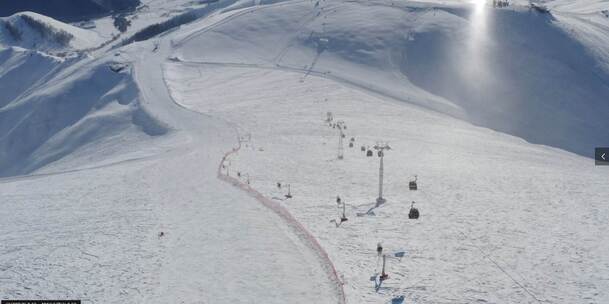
0 38 339 303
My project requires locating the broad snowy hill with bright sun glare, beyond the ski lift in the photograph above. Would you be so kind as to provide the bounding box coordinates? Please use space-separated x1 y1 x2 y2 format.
172 2 609 156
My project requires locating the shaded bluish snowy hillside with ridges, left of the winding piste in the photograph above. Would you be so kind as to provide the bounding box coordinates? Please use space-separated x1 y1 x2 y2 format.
0 48 167 176
